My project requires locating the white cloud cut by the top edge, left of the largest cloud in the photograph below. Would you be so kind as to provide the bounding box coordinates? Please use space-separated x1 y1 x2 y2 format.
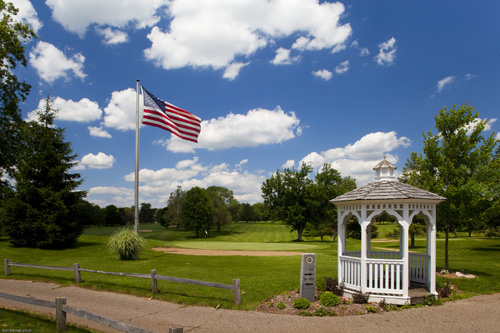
45 0 167 37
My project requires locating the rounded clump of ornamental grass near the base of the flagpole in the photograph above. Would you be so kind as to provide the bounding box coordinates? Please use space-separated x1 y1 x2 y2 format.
107 229 146 260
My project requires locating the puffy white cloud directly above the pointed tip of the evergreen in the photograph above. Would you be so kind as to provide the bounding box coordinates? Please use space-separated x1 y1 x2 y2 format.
30 41 87 83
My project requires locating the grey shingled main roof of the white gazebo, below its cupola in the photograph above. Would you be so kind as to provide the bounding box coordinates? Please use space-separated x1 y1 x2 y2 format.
330 180 446 202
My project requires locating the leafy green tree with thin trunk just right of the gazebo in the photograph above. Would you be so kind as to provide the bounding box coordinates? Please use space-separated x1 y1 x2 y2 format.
401 104 500 270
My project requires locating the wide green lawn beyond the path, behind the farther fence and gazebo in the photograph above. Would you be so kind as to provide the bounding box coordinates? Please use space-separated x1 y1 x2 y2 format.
0 223 500 309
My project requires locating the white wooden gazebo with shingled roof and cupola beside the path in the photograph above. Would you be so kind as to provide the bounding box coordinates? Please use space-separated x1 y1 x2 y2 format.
330 156 446 305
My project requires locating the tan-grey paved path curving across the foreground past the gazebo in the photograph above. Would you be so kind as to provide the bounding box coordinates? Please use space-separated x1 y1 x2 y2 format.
0 279 500 333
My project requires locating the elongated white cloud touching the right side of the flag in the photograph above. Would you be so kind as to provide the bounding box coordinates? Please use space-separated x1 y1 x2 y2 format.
157 106 301 152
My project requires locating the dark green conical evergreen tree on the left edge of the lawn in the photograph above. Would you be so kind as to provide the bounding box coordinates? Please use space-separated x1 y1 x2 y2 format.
5 99 86 248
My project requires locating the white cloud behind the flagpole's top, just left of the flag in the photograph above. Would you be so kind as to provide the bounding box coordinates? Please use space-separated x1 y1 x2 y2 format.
104 88 142 131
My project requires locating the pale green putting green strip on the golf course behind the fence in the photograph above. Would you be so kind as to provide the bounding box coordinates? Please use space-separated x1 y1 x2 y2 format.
168 241 328 252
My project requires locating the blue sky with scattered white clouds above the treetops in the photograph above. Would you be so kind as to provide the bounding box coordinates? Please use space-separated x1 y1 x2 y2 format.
13 0 500 207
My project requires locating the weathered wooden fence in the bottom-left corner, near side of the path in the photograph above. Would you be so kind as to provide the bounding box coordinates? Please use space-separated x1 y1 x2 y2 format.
0 293 152 333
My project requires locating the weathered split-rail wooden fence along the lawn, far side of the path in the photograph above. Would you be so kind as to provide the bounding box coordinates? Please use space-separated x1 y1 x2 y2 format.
4 259 241 305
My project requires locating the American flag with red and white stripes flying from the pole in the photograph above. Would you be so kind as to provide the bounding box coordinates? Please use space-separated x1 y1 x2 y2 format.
142 87 201 142
